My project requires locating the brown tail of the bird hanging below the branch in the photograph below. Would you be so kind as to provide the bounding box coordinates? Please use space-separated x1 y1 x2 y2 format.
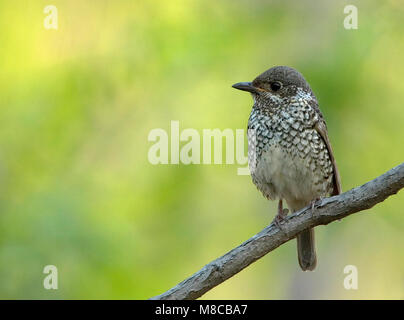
297 229 317 271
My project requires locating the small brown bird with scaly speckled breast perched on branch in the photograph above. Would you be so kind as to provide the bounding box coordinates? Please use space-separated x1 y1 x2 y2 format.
233 66 341 271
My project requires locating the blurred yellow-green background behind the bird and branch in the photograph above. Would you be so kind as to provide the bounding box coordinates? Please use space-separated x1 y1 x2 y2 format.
0 0 404 299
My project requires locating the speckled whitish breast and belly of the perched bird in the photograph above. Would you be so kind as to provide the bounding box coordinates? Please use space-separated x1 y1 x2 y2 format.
248 89 333 210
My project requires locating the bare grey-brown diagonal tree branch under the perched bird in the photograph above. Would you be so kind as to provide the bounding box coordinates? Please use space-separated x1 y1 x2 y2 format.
151 163 404 300
